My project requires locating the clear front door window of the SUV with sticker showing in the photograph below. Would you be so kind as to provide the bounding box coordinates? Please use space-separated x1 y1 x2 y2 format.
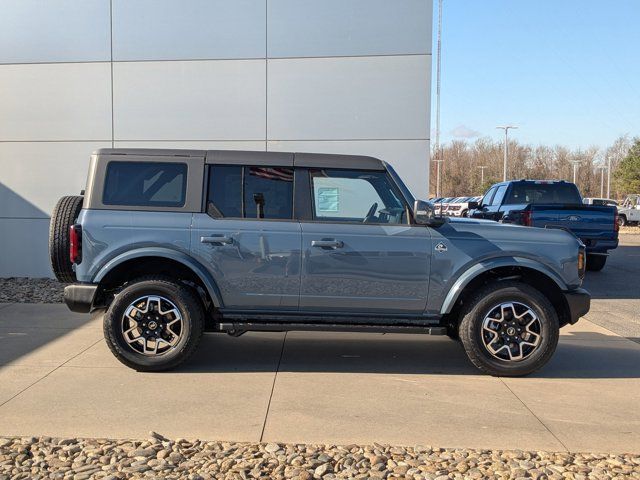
310 169 407 224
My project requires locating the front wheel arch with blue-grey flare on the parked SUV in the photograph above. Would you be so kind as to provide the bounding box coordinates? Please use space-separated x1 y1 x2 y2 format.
440 259 571 327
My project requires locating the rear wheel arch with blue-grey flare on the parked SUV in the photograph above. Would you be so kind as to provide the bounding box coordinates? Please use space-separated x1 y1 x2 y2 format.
93 248 223 308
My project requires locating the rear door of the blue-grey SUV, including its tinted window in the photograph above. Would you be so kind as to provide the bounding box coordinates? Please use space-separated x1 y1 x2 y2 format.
191 158 301 310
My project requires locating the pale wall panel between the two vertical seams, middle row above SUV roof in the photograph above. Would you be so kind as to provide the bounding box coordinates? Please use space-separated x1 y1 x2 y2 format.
113 60 266 140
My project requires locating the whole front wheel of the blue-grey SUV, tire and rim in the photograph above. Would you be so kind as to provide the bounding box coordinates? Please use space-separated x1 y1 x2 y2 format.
459 281 559 377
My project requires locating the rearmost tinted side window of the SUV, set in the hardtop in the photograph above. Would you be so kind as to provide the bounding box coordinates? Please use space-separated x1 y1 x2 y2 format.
102 162 187 207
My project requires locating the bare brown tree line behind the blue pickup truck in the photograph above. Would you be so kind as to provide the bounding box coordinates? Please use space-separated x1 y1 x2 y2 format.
429 135 640 200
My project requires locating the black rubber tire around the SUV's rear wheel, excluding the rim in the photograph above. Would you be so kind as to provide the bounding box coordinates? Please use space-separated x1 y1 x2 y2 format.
103 276 204 372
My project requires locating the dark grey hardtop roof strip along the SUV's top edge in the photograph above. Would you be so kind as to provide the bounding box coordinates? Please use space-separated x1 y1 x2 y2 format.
93 148 386 170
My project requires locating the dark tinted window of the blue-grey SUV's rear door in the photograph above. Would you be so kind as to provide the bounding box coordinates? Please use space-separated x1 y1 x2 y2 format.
207 165 293 220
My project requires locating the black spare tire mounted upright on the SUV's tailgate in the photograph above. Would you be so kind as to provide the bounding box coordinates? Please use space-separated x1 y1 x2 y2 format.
49 196 84 283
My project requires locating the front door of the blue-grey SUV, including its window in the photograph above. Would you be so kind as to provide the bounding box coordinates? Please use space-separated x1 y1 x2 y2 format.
300 169 430 314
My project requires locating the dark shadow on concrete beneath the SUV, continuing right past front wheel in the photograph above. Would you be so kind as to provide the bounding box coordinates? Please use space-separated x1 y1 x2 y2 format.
178 332 640 379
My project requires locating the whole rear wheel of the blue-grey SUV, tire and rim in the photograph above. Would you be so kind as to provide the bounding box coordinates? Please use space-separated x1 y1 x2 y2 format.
103 277 204 372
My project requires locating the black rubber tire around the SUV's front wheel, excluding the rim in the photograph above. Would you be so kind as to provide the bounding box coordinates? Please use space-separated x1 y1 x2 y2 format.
458 281 559 377
